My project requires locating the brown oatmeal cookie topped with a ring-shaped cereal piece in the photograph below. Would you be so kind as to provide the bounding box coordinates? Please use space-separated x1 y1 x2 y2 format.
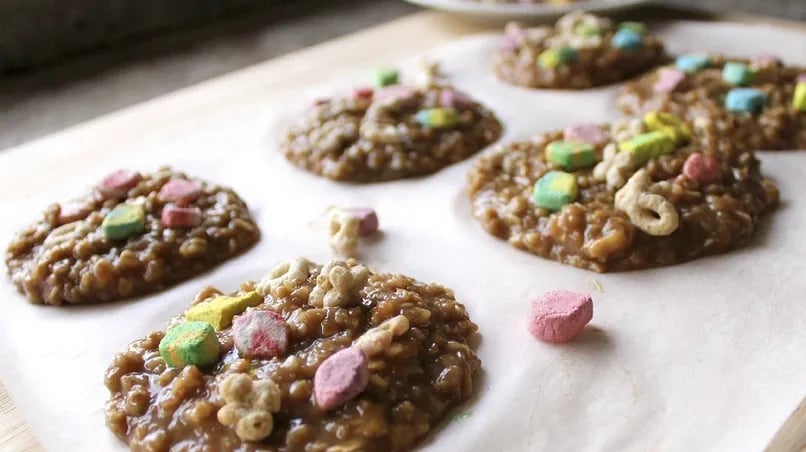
469 119 778 272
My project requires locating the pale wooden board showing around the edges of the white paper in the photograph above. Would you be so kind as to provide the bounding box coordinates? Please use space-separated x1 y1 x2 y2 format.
0 7 806 452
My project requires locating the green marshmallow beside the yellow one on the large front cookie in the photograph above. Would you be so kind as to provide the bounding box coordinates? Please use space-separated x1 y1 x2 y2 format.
159 322 221 367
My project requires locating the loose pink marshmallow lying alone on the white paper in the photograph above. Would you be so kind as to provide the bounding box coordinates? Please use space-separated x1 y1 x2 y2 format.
527 290 593 343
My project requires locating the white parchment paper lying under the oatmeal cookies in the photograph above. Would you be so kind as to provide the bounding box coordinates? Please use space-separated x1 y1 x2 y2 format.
0 22 806 452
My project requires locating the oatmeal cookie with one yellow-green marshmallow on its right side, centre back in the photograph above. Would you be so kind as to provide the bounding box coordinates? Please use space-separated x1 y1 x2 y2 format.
281 80 502 182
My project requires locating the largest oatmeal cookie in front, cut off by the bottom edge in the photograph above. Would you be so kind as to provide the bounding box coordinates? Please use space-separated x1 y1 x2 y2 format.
105 259 480 452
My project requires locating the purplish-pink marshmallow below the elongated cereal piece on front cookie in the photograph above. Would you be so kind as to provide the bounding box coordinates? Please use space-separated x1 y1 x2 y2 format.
313 347 369 411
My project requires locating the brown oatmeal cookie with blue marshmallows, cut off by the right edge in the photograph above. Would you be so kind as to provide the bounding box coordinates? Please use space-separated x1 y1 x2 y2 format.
618 54 806 151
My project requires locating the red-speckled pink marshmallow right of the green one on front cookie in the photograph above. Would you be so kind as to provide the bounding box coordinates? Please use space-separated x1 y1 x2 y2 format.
232 310 288 359
